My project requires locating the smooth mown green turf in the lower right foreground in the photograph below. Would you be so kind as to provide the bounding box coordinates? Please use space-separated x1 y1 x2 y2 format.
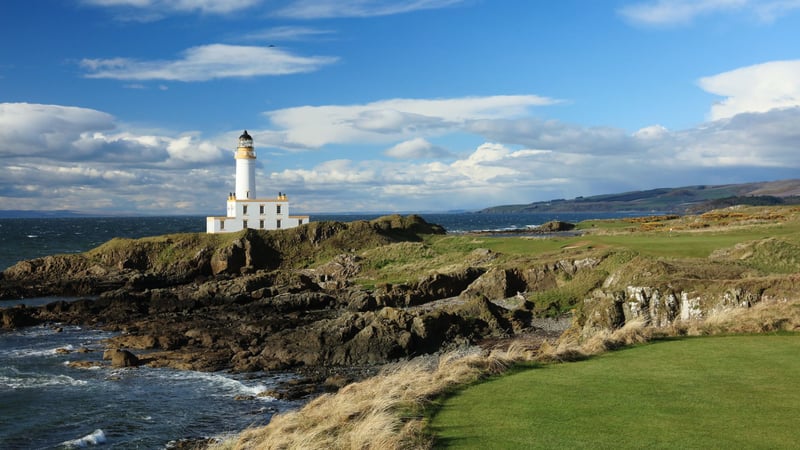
432 335 800 449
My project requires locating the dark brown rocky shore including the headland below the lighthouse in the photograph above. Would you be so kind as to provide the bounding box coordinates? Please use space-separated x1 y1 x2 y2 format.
0 216 575 398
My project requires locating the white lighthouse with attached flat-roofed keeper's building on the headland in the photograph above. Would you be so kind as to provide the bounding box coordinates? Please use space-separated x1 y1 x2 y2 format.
206 130 309 233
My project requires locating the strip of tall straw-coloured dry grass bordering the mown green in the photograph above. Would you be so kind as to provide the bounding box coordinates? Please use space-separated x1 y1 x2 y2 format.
212 299 800 450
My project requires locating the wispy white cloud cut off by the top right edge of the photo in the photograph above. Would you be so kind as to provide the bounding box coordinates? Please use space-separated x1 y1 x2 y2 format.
618 0 800 26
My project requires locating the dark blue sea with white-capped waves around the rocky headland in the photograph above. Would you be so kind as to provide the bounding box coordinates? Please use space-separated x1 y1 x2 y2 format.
0 213 635 449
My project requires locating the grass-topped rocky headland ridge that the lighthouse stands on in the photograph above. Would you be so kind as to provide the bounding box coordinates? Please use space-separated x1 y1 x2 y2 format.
0 216 445 299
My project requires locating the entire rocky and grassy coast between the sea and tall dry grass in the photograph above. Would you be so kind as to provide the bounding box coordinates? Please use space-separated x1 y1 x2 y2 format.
0 208 800 446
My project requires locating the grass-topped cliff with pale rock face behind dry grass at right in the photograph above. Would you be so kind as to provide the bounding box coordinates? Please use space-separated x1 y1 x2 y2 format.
565 238 800 341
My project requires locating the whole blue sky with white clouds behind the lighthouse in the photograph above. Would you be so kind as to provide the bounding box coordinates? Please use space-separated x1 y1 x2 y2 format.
0 0 800 219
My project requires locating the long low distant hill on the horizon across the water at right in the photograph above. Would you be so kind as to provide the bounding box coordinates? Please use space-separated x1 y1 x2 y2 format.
479 179 800 214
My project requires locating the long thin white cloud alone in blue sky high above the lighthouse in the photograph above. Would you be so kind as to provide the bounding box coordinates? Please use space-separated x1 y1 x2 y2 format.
81 44 337 81
